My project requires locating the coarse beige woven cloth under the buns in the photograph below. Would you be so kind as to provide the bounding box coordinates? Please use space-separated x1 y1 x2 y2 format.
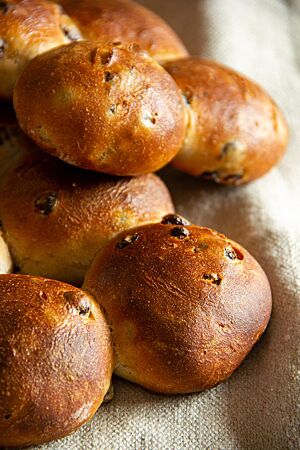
39 0 300 450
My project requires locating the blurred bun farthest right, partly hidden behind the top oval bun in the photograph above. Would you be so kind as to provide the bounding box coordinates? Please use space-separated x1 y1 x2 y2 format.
165 57 288 185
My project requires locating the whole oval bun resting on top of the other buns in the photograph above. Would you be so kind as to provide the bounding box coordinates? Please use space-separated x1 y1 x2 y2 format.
14 42 186 176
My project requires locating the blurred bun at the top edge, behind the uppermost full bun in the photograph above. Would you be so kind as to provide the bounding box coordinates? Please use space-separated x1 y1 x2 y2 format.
59 0 187 62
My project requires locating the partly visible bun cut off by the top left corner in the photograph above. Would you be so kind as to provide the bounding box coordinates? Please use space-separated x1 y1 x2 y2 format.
0 0 81 99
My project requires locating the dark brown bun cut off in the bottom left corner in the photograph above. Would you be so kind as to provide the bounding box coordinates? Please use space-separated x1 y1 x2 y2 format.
0 275 114 447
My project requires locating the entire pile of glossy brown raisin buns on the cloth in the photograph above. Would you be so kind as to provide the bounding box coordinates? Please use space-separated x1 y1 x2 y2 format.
0 0 288 447
